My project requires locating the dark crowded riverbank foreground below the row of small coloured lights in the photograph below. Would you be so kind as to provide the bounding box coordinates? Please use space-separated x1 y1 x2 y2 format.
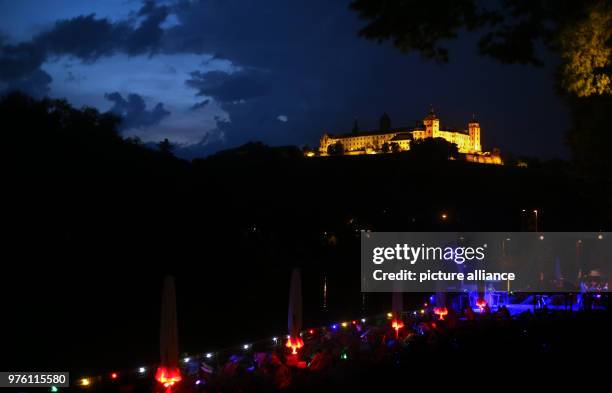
64 311 610 393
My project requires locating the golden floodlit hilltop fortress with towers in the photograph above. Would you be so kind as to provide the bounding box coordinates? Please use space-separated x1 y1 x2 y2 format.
319 109 502 165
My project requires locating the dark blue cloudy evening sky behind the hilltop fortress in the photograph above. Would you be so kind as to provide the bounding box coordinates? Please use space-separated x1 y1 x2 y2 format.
0 0 568 158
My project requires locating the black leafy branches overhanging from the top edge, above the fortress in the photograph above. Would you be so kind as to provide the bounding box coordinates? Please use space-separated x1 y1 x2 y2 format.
350 0 603 65
